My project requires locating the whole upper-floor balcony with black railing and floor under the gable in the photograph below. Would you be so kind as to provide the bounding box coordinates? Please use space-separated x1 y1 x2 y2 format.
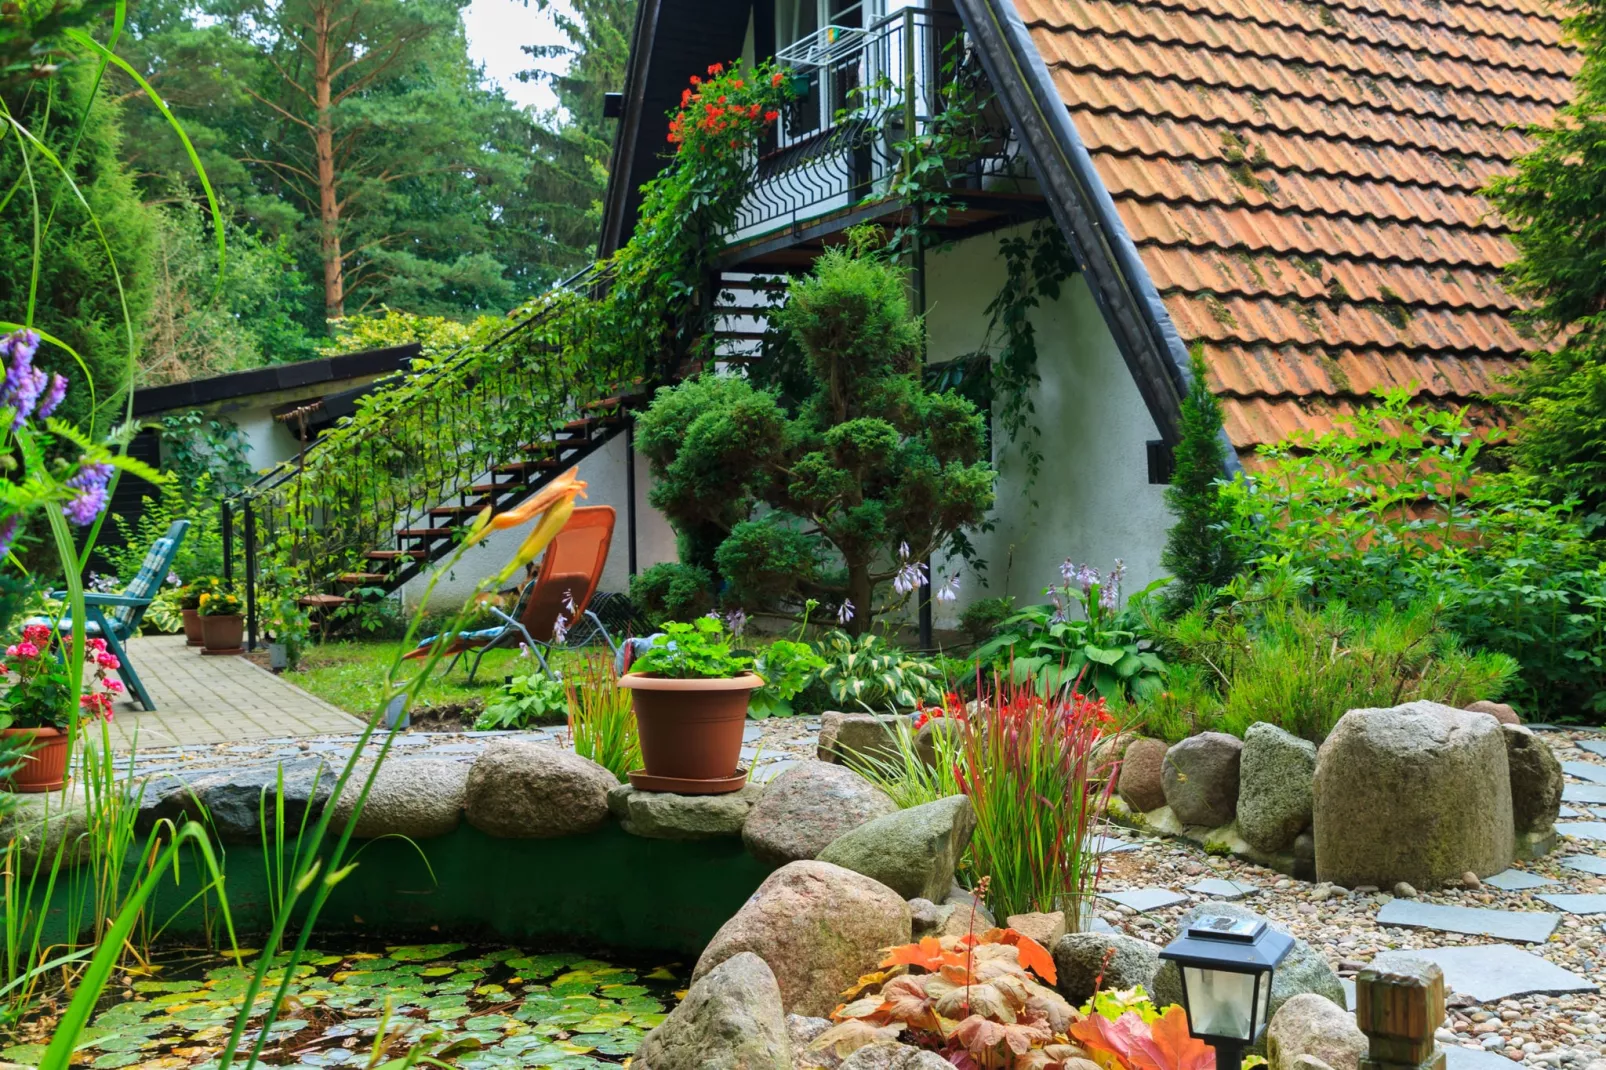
726 8 1044 270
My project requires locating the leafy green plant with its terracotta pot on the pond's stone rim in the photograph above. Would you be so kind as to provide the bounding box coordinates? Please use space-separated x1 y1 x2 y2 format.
618 617 764 795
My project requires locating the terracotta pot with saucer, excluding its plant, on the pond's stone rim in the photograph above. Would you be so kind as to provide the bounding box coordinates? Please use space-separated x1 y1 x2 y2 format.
618 673 764 795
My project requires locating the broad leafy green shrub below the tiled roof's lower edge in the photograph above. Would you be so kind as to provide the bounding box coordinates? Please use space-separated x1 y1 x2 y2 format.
1229 390 1606 720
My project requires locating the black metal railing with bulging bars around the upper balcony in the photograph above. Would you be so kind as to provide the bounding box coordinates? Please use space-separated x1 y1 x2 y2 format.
729 8 1026 243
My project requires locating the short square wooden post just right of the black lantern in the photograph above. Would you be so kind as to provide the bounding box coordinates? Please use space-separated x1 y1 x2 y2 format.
1355 959 1445 1070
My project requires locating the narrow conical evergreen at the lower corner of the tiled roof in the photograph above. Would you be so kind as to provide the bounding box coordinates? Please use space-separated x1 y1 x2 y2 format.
1160 345 1243 612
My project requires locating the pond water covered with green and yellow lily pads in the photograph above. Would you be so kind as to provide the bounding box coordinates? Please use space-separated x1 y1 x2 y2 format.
18 943 684 1070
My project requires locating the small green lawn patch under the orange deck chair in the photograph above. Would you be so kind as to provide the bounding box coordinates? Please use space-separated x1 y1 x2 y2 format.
284 639 605 717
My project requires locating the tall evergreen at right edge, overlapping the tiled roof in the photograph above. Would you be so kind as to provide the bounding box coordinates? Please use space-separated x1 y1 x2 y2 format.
1489 3 1606 523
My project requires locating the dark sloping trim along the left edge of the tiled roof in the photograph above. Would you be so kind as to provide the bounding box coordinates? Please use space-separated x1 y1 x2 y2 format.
957 0 1214 453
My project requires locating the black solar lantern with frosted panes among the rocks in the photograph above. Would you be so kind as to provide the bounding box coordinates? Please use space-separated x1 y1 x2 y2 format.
1160 914 1294 1070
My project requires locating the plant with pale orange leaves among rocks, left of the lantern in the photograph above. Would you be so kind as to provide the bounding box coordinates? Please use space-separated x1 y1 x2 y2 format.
814 929 1086 1070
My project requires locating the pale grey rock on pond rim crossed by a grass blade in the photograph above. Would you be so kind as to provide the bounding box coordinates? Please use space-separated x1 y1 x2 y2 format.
331 757 469 840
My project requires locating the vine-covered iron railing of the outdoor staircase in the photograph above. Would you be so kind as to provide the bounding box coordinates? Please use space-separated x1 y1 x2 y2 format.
223 268 641 641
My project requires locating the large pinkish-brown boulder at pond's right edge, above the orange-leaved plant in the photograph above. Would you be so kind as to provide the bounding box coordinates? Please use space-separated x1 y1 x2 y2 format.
692 861 909 1015
